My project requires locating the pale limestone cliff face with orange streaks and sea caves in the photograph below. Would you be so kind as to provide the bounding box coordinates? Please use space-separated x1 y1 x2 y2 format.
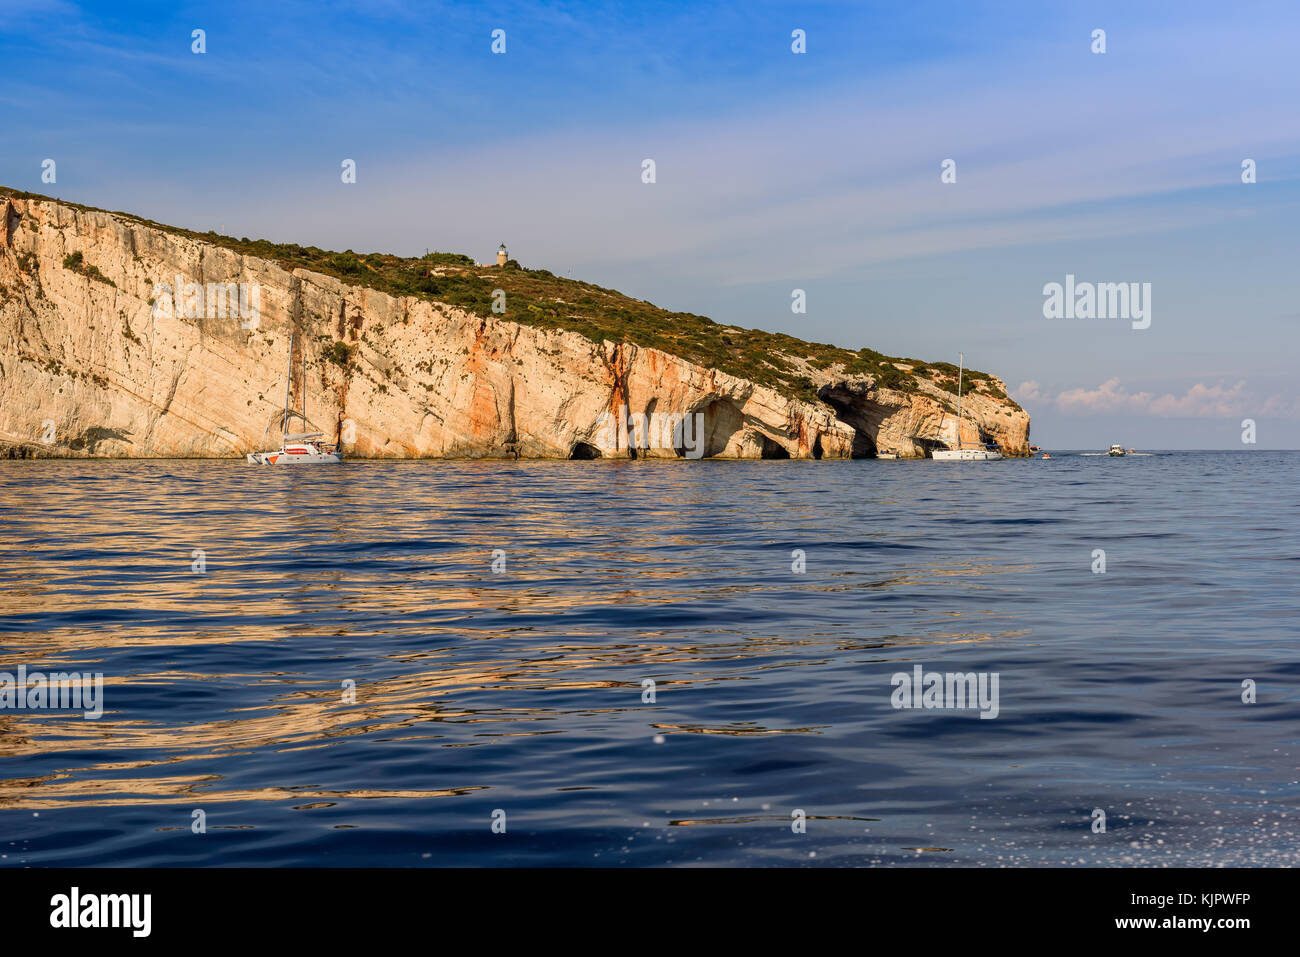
0 196 1028 458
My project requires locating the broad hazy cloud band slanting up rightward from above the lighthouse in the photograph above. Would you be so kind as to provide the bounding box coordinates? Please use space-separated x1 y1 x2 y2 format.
116 14 1300 285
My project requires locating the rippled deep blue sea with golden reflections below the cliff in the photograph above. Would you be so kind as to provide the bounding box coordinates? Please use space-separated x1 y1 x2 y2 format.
0 451 1300 866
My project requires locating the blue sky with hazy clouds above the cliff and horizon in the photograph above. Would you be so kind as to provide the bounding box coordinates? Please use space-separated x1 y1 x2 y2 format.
0 0 1300 449
